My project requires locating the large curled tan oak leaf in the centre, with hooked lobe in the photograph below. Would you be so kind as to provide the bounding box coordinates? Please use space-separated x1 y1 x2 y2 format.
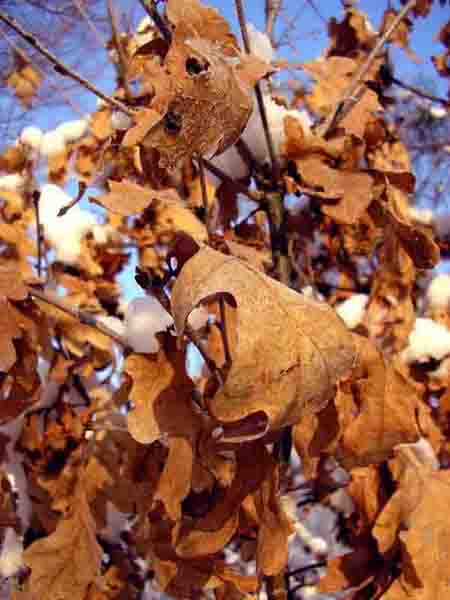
171 247 355 429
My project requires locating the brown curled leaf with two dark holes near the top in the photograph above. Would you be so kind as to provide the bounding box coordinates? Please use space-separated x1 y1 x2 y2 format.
143 32 253 170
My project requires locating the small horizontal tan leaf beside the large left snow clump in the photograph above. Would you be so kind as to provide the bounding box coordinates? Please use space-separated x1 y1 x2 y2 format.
95 179 178 217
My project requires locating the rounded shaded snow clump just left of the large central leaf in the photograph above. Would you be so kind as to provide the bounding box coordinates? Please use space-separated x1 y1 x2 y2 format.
125 296 173 354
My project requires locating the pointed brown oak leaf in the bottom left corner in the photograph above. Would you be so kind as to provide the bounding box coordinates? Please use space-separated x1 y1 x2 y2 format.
24 483 103 600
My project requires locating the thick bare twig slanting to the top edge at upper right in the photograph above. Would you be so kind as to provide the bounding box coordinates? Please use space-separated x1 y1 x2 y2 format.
318 0 417 137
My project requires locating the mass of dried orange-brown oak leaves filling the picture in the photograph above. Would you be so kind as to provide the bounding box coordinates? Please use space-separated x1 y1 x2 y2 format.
0 0 450 600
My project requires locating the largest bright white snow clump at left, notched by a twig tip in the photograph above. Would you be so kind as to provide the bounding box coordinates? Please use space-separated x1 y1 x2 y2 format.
39 184 97 264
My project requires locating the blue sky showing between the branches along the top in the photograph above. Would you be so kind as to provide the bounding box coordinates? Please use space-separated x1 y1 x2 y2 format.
0 0 450 135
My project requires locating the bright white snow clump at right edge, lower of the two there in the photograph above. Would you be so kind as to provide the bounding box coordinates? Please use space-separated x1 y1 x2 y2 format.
402 318 450 364
